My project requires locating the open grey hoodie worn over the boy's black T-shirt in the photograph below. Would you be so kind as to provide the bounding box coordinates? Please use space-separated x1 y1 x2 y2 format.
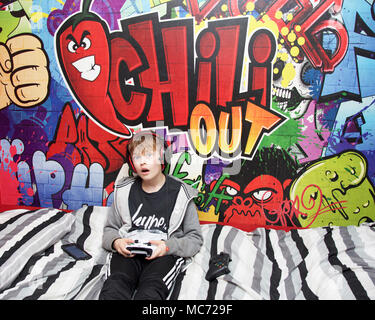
103 176 203 258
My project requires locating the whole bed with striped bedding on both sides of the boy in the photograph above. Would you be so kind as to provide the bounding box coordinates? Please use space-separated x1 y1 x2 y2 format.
0 206 375 300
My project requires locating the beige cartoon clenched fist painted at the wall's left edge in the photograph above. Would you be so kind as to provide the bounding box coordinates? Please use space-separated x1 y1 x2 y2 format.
0 34 50 109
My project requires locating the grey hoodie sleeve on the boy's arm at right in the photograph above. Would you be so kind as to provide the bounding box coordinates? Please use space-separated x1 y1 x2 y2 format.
166 201 203 258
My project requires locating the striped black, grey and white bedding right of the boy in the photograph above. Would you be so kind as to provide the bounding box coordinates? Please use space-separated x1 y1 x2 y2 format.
179 223 375 300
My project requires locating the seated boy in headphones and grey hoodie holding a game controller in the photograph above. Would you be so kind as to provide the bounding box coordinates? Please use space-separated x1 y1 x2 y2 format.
99 131 203 300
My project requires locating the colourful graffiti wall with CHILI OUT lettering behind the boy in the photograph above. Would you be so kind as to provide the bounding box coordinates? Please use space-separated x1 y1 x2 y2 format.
0 0 375 231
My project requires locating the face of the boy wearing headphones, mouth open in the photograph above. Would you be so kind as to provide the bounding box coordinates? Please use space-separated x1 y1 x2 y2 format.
132 144 162 180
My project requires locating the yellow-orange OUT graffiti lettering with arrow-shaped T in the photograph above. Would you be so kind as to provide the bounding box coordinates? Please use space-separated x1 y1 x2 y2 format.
189 101 282 158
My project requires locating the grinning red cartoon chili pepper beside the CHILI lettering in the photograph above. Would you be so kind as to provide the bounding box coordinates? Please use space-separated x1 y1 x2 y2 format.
56 0 132 138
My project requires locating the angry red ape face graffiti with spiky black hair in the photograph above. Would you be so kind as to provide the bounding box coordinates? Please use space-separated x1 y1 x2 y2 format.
201 148 300 231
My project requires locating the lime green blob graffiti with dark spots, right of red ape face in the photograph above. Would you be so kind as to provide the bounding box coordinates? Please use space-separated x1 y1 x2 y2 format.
290 151 375 228
